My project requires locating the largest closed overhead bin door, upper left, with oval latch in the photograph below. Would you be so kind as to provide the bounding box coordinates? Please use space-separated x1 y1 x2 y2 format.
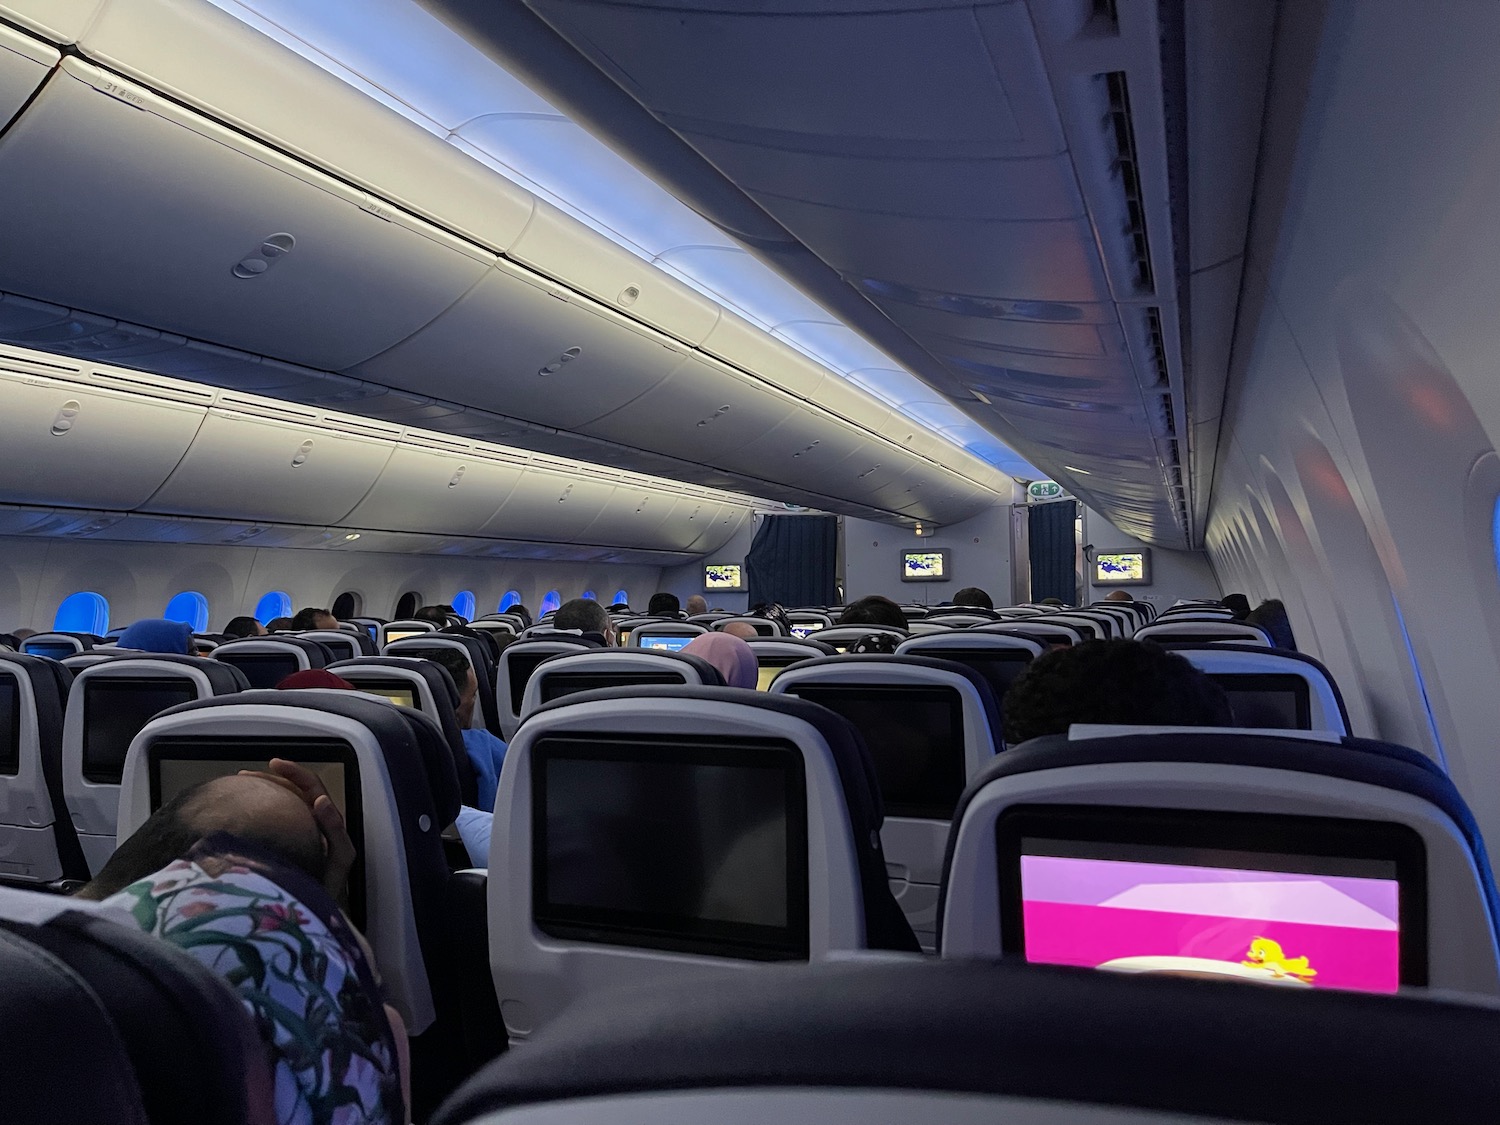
0 57 494 369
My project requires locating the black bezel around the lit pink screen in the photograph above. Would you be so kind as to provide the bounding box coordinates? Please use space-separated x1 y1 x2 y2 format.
995 804 1428 987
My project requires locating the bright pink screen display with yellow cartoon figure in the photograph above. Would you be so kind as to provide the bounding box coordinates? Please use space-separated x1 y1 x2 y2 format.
1022 855 1401 992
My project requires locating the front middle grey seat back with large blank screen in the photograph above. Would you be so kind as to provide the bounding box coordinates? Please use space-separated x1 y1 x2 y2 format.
489 687 917 1040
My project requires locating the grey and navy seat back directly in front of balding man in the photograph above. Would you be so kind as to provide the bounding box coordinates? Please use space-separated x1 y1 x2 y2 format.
119 689 459 1035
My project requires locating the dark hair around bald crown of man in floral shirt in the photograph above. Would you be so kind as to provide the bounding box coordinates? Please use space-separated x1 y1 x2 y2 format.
78 777 329 900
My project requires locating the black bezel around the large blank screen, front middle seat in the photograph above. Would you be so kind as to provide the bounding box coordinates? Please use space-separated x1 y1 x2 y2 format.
531 734 810 962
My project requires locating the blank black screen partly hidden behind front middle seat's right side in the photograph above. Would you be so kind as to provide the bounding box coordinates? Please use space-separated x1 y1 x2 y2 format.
791 684 968 821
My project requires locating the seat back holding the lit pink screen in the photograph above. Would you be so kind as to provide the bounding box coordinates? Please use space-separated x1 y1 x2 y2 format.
942 726 1500 995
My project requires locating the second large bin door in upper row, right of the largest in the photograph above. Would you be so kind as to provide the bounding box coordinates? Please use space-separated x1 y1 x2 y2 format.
350 261 684 444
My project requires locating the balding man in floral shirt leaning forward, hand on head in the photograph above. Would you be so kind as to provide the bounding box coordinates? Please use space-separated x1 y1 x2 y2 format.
80 759 410 1125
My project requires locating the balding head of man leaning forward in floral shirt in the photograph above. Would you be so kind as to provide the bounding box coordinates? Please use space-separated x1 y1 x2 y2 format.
78 774 327 900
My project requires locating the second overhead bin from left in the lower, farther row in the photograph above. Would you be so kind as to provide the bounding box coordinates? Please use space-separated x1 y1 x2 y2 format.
143 395 401 524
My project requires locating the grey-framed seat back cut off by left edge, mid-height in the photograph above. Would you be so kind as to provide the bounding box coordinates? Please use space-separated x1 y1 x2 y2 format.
0 653 89 882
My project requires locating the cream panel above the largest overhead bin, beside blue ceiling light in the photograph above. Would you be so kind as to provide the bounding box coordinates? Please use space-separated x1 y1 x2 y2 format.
83 0 533 251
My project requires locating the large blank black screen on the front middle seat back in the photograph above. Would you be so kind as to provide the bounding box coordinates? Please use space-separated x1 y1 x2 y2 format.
533 737 807 960
